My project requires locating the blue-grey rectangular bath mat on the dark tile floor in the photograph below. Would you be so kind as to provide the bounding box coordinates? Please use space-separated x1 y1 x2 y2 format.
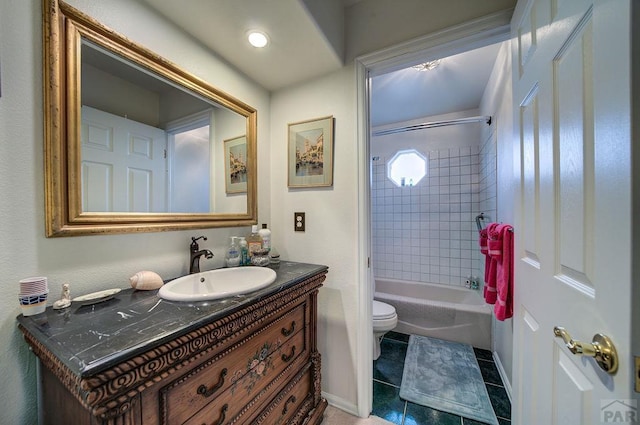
400 335 498 425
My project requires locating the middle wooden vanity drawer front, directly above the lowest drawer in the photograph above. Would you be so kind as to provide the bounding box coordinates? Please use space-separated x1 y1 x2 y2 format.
184 332 309 425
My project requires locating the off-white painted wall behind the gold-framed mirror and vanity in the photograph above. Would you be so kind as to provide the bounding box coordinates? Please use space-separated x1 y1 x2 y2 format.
0 0 268 425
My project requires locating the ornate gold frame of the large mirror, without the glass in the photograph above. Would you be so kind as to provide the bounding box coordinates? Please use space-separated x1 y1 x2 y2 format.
43 0 257 237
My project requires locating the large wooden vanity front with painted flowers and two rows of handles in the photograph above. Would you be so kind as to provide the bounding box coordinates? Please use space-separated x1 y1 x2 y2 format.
160 304 309 425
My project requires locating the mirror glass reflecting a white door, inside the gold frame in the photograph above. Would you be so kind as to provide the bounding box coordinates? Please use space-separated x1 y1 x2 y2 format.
81 39 247 213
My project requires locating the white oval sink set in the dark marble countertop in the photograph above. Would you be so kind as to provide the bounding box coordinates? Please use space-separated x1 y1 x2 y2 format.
158 266 276 301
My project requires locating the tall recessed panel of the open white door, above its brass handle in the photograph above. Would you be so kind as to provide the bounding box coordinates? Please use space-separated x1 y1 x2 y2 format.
552 9 594 296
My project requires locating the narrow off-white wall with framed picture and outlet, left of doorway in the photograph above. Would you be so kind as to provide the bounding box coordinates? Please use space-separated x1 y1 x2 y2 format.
270 66 360 412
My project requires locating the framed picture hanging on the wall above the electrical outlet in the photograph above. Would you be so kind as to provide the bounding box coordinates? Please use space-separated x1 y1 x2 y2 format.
288 116 334 188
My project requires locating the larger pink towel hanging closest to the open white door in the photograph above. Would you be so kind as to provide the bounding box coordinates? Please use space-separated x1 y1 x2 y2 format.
496 224 513 320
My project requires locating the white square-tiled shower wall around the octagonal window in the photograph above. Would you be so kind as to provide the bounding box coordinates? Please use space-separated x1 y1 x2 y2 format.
371 124 496 286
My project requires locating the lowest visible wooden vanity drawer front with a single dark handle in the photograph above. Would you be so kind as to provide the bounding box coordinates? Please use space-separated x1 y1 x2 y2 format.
251 365 313 425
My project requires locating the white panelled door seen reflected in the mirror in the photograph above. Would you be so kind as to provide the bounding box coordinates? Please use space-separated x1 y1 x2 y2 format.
81 106 167 213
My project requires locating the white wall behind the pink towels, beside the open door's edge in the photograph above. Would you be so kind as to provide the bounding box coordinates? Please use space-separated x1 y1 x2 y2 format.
480 41 518 386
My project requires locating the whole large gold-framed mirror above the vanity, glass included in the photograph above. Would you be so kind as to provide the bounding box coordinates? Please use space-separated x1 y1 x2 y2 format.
43 0 257 237
